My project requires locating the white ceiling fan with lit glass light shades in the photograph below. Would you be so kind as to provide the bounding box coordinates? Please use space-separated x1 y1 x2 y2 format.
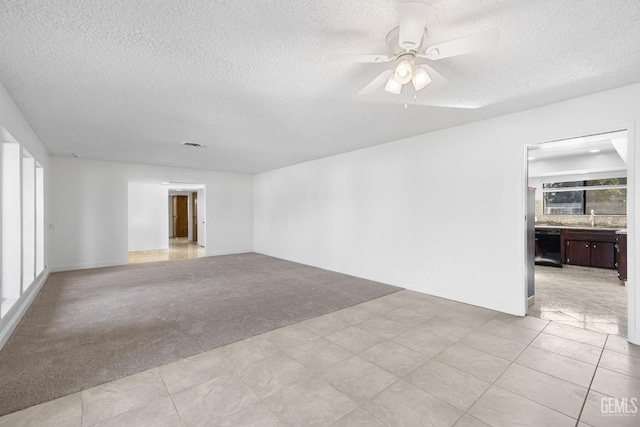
339 2 500 95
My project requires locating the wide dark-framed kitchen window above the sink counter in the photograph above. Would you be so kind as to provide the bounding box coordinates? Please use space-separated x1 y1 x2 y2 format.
542 178 627 215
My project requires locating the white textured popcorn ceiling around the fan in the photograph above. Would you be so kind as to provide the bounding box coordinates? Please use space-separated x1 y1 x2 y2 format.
0 0 640 173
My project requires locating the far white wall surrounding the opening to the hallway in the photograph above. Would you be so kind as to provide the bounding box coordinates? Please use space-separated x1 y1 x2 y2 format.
50 157 253 271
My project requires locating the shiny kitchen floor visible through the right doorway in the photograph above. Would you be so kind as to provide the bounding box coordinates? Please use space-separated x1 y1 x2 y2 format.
529 265 627 336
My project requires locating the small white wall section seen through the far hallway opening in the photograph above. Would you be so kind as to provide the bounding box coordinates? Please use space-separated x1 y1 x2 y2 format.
128 181 169 251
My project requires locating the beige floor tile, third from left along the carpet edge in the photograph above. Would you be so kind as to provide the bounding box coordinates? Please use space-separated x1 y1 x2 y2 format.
159 350 233 393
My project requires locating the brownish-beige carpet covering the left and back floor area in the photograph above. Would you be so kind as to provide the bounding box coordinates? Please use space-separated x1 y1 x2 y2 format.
0 253 401 415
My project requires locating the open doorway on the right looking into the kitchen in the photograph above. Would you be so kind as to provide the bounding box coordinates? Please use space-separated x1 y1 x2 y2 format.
526 130 631 337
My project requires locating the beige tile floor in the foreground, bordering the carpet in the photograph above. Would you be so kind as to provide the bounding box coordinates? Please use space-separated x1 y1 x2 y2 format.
0 291 640 427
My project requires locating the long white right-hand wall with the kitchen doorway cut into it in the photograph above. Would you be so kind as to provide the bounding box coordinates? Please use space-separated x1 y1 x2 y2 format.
254 85 640 342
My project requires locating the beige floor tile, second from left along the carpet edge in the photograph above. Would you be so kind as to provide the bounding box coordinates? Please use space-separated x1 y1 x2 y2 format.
82 368 169 426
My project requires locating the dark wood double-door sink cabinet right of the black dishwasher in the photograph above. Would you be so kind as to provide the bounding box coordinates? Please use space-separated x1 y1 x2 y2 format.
562 229 618 269
